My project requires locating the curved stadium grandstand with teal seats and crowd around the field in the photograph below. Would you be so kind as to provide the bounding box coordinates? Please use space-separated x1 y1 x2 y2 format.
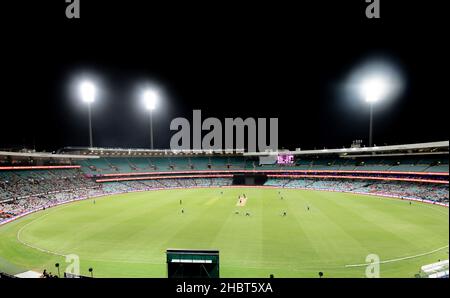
0 142 449 223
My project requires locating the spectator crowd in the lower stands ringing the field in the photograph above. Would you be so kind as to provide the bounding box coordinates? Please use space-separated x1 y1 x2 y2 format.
0 169 449 223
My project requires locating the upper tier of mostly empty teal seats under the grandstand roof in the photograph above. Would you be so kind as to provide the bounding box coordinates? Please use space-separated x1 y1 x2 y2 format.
72 155 448 174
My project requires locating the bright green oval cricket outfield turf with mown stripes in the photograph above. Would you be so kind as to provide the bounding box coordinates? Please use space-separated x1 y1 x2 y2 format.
0 188 449 277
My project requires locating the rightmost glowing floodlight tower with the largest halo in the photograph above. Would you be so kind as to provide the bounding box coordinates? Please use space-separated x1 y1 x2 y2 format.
360 75 389 147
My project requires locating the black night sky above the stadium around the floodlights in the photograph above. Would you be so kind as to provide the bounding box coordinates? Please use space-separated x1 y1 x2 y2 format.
0 0 449 151
